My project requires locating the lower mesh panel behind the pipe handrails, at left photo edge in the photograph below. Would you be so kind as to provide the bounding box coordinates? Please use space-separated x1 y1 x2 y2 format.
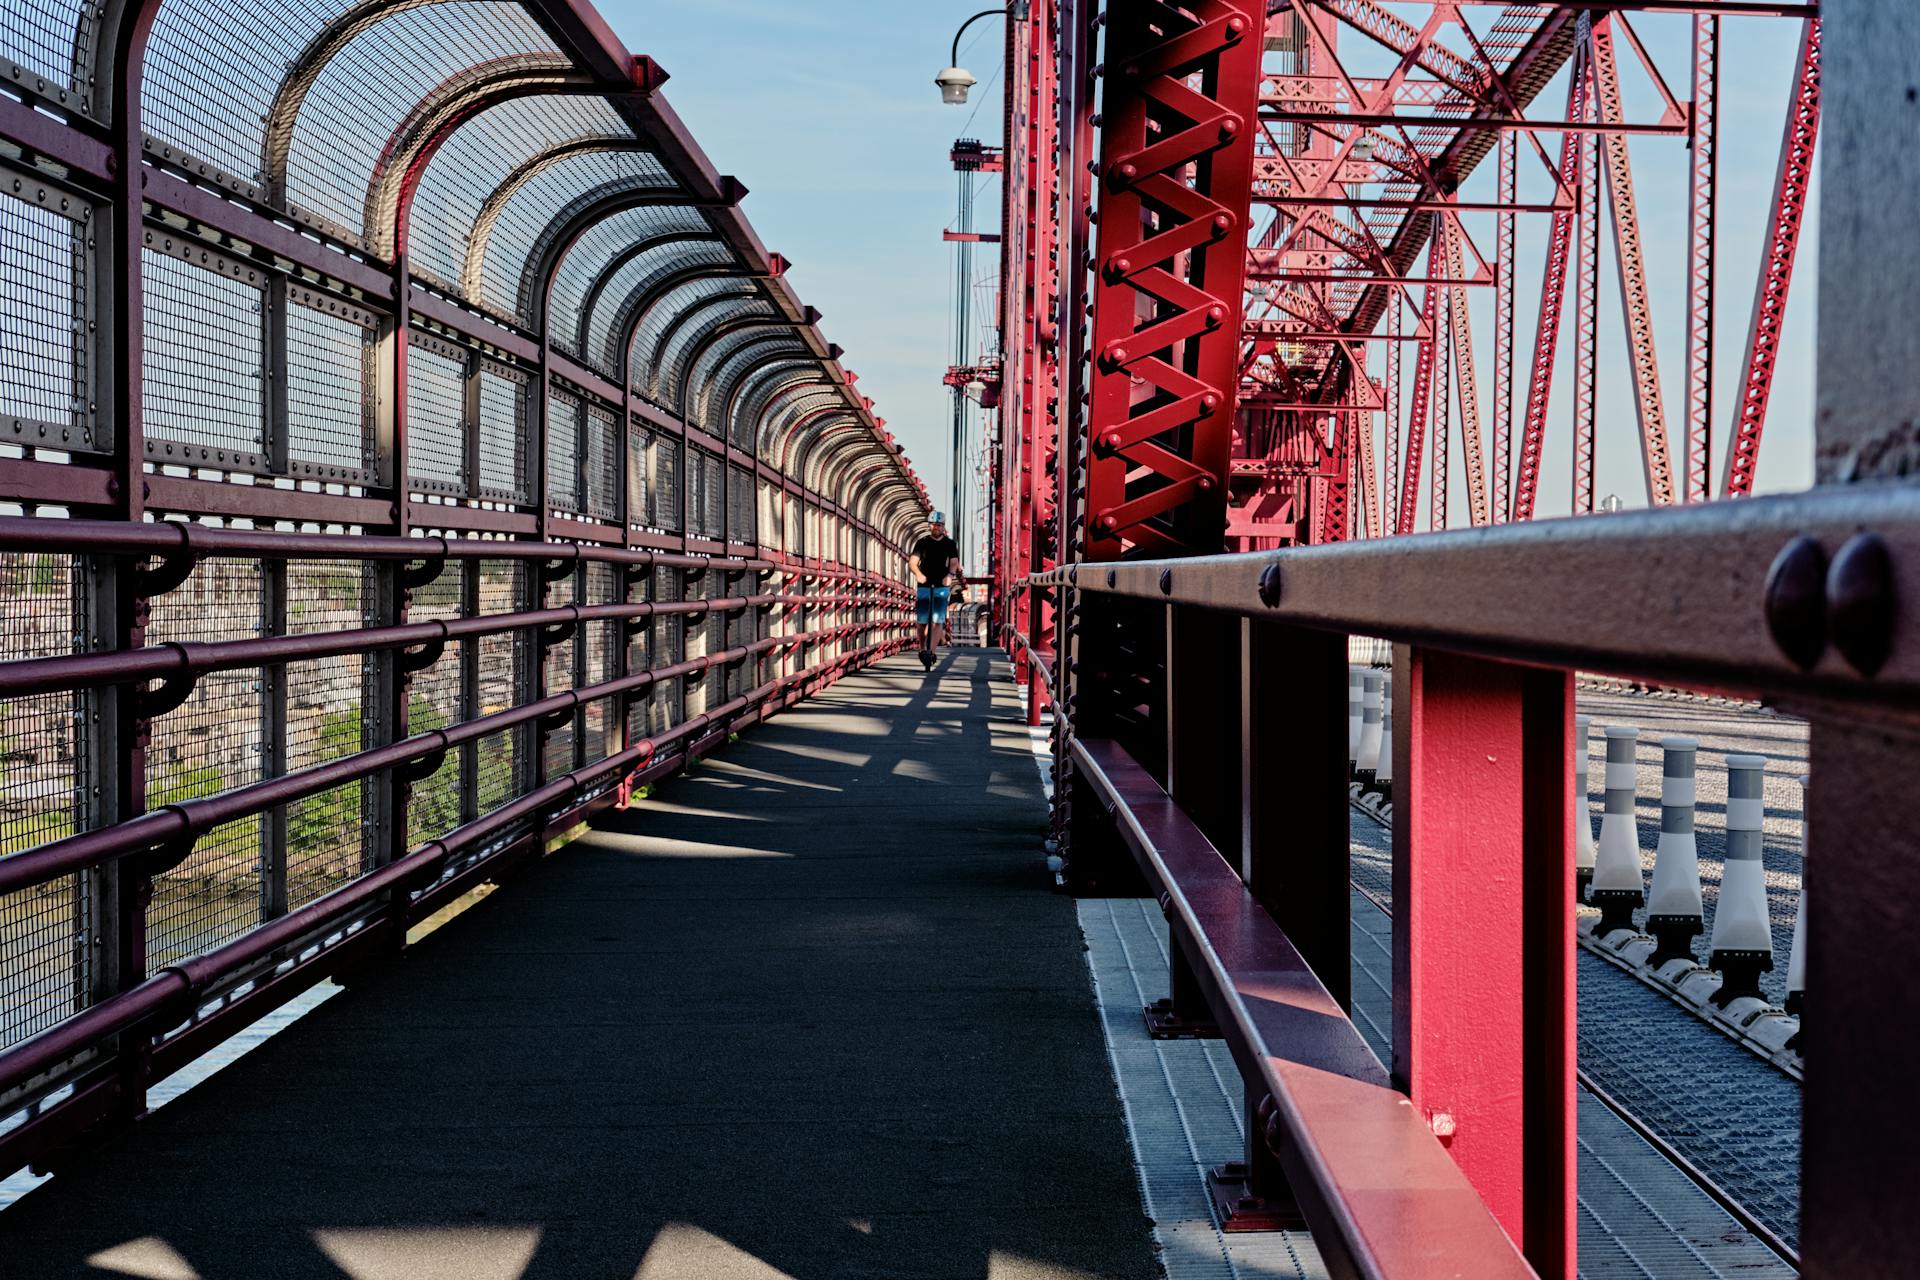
0 555 92 1048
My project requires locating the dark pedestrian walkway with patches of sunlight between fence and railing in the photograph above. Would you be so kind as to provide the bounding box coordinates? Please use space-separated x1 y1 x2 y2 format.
0 651 1160 1280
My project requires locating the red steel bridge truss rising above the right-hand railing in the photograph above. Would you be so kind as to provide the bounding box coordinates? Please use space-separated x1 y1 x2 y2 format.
995 0 1820 652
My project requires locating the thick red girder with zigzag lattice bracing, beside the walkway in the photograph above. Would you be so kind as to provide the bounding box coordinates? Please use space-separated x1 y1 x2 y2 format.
1085 0 1261 558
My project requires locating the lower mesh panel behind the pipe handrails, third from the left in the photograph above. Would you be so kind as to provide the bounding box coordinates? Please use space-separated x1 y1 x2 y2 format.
284 560 376 908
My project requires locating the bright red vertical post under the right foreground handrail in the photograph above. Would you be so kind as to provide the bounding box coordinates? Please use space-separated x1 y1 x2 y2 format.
1392 645 1574 1278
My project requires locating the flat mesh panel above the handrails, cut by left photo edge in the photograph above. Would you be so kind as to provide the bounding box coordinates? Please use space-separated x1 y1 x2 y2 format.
0 196 94 449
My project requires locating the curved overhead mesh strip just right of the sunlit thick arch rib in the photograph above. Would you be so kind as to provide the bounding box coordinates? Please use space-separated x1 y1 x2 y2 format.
407 94 634 295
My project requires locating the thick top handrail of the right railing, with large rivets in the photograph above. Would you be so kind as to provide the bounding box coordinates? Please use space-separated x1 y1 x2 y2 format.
1027 484 1920 708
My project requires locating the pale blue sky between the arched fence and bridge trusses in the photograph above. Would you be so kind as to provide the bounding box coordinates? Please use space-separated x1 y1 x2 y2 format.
603 0 1818 524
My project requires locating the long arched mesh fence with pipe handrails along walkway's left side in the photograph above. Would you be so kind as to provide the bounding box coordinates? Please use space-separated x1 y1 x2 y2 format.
0 0 929 1171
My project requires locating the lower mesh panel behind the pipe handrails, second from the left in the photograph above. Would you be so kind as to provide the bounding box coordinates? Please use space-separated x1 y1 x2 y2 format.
146 560 265 965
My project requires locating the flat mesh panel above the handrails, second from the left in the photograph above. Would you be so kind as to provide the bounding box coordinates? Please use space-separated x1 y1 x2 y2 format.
140 249 265 461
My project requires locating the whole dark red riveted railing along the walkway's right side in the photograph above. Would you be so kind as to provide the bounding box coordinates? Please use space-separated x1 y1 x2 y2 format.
1029 484 1920 1276
